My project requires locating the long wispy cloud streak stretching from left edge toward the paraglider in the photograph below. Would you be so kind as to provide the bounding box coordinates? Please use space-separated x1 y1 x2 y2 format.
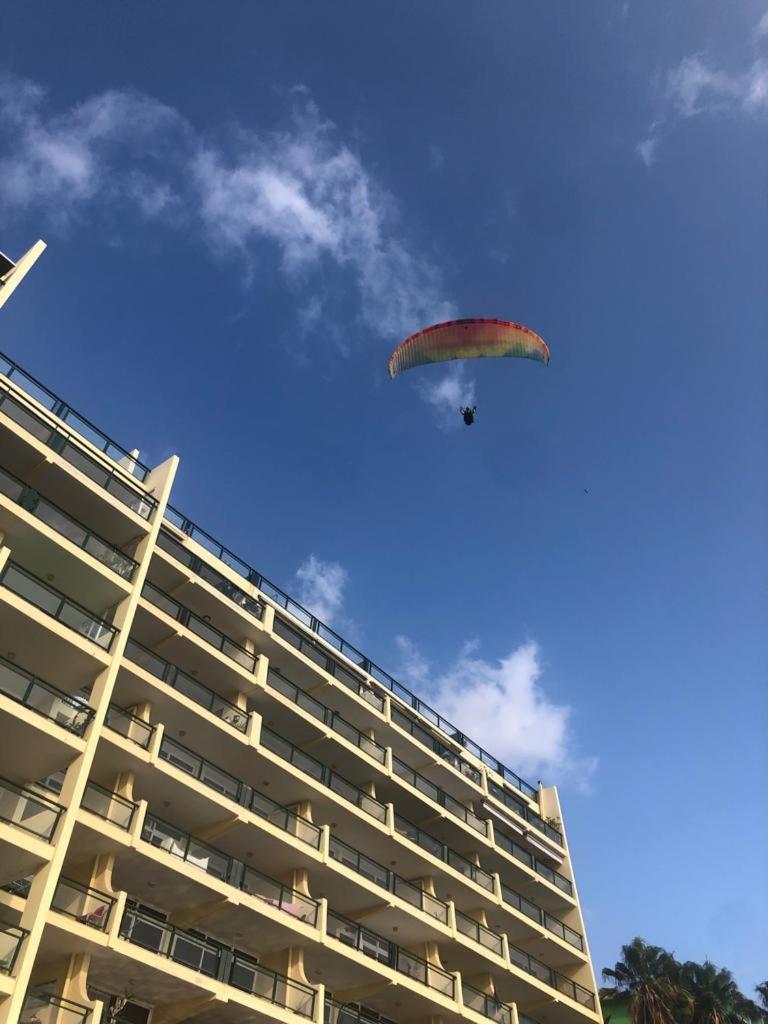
0 75 455 345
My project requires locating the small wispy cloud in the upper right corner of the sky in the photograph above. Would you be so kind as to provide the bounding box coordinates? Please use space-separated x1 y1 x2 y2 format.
635 11 768 167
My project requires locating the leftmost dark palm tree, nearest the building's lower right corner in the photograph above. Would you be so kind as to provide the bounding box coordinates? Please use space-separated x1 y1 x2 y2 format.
603 938 689 1024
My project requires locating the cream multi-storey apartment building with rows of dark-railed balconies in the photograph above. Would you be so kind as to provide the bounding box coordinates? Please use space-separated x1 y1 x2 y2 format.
0 344 601 1024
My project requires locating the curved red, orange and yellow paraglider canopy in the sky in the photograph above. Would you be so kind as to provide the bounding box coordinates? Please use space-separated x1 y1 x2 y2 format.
387 317 549 378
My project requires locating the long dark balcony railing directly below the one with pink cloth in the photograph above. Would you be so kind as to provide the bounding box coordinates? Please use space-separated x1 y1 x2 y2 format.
120 904 315 1017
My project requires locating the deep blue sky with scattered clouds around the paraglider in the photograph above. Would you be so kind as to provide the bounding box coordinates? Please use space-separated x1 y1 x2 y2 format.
0 0 768 989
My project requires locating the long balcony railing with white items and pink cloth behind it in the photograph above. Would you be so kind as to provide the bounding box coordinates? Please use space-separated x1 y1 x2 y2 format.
141 814 318 926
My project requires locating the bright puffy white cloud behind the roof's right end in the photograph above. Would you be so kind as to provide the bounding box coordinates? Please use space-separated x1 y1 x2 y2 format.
396 637 597 791
